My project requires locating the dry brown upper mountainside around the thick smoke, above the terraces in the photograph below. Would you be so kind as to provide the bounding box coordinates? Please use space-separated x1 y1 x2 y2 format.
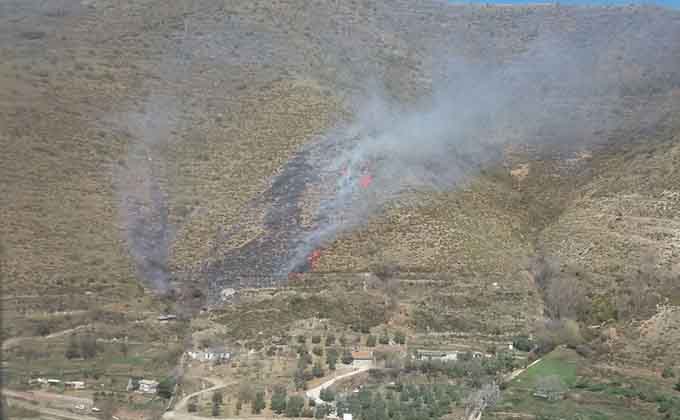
0 0 680 370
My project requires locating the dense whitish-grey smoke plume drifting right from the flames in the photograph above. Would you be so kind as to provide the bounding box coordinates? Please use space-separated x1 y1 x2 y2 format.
284 28 679 271
